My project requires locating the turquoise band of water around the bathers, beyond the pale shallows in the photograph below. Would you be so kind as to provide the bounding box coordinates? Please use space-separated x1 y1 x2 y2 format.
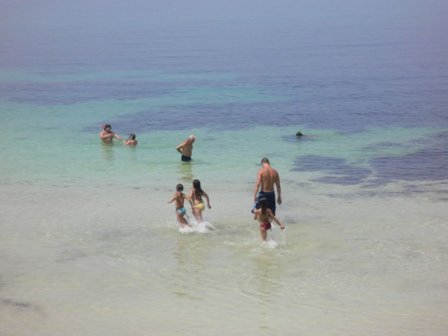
1 67 446 183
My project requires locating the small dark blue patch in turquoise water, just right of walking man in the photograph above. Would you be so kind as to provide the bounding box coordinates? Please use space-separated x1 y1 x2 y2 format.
292 155 372 185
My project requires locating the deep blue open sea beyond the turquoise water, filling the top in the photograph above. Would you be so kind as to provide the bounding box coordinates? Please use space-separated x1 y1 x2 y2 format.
0 1 448 136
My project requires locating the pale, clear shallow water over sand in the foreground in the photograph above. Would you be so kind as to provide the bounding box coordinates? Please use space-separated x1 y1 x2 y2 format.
0 181 448 335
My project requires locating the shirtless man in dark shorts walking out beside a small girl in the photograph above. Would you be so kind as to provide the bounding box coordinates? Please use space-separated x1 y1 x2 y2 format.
254 158 282 216
